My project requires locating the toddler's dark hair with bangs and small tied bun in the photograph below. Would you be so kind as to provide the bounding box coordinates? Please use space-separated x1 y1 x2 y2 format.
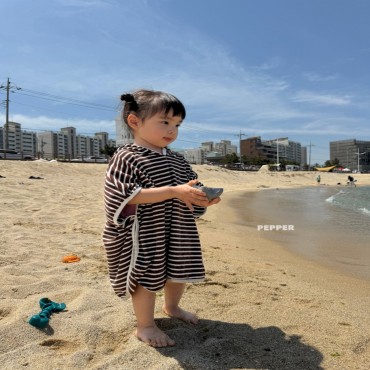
121 90 186 124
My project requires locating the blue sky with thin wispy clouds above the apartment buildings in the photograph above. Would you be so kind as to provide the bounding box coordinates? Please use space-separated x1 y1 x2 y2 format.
0 0 370 164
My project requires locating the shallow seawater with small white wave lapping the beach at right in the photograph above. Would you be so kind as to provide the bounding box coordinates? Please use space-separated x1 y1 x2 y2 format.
234 185 370 280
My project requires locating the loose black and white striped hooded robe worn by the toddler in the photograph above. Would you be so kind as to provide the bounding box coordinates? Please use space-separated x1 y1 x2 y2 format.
103 144 205 298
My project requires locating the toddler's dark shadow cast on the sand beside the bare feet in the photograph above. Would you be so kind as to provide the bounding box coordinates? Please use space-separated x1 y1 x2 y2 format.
156 318 323 370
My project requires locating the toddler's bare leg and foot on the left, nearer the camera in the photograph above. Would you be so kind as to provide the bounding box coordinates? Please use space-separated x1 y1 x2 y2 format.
132 285 175 347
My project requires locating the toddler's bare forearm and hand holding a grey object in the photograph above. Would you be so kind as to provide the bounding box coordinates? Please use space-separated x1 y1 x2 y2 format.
129 180 211 211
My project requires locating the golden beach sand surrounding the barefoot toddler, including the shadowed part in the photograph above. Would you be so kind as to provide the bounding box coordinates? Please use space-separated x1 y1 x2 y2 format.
0 161 370 370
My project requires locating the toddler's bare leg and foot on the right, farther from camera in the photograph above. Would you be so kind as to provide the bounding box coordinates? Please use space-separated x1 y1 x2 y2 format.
163 281 198 324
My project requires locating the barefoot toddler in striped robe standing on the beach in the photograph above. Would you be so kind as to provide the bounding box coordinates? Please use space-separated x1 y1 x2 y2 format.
103 90 220 347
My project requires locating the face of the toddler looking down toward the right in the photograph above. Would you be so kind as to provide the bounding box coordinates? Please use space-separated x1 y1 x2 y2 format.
130 111 182 152
